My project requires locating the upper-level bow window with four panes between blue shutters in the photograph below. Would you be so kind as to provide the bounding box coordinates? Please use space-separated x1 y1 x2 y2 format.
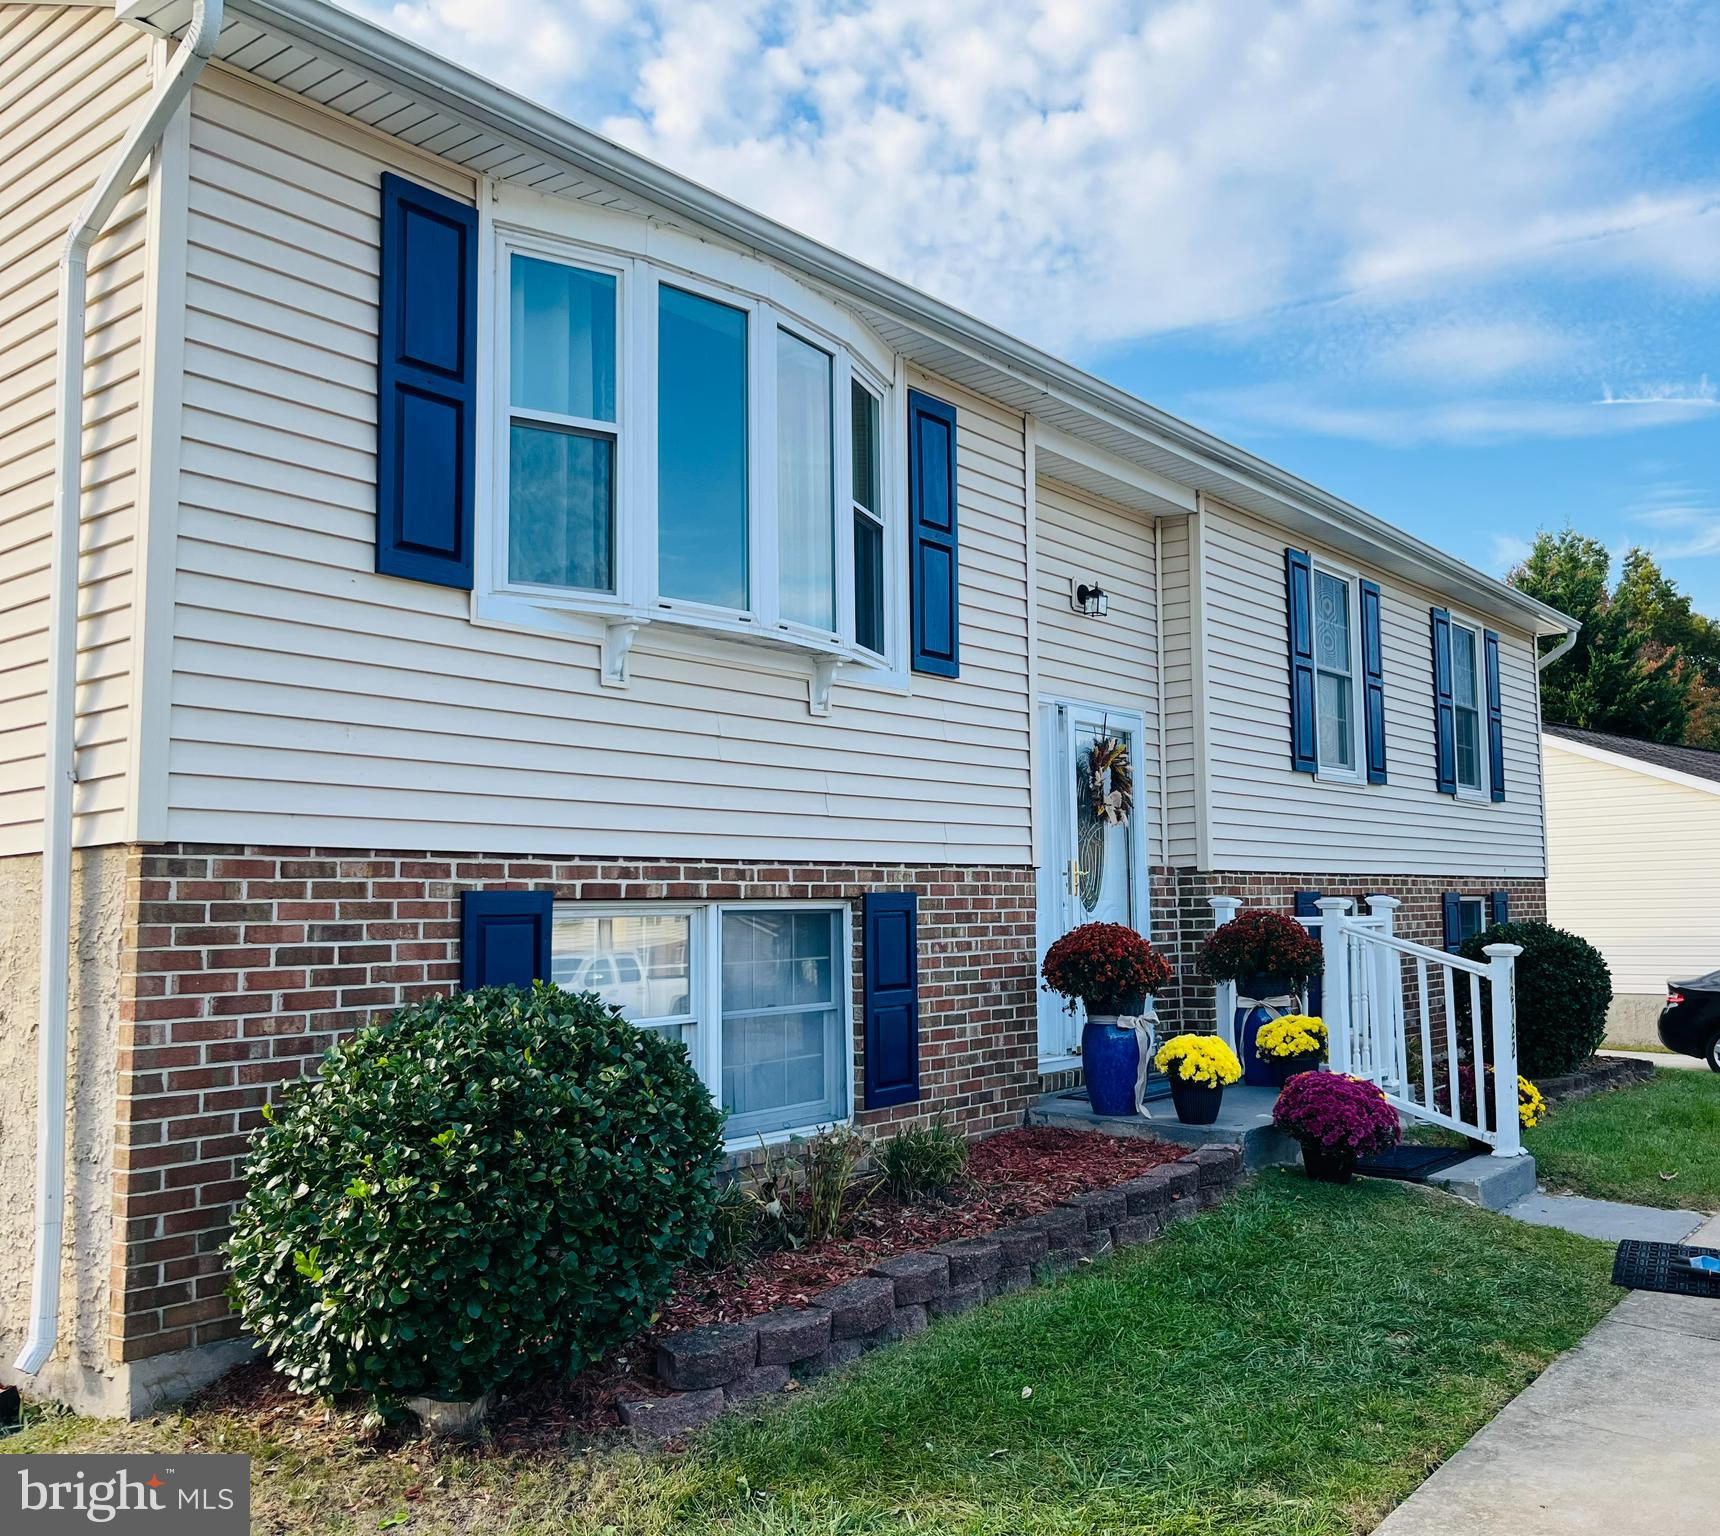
485 232 906 670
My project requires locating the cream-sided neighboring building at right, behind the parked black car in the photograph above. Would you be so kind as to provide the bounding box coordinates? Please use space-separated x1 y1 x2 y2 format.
1541 726 1720 1044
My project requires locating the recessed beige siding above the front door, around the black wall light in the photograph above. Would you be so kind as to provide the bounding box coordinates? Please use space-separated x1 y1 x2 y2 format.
1035 480 1163 860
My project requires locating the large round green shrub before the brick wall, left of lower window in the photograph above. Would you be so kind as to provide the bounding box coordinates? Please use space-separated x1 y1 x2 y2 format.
227 984 722 1400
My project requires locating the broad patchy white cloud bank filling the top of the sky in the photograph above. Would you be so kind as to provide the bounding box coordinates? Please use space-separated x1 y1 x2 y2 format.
347 0 1720 352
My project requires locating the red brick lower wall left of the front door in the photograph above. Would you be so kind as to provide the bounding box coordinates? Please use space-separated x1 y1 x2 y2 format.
110 845 1039 1361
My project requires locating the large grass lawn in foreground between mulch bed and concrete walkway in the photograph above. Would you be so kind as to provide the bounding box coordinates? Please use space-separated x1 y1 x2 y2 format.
3 1173 1617 1536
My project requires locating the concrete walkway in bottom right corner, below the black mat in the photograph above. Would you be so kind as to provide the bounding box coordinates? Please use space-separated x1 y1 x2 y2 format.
1376 1216 1720 1536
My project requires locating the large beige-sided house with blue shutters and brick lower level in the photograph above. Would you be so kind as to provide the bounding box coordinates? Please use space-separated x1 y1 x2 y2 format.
0 0 1572 1409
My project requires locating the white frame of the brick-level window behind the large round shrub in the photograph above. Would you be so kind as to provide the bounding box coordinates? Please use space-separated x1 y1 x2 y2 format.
550 901 855 1151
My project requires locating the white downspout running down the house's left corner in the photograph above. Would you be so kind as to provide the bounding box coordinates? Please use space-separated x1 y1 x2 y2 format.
14 0 222 1376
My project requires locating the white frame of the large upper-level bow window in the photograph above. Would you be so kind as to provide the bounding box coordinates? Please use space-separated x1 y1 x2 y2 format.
473 208 908 690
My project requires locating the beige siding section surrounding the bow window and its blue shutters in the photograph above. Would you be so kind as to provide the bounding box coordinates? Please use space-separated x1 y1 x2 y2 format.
169 72 1030 863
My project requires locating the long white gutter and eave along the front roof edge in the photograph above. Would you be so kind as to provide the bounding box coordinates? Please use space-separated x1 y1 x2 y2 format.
134 0 1576 635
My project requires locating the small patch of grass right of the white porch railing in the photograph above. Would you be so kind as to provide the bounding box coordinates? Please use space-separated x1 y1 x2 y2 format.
1524 1068 1720 1211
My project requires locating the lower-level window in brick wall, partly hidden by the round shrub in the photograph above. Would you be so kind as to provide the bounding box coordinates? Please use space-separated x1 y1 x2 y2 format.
550 903 850 1142
